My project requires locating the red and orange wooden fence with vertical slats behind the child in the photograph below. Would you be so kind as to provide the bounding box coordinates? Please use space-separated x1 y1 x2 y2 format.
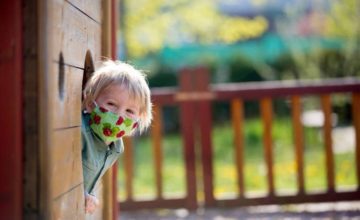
120 68 360 210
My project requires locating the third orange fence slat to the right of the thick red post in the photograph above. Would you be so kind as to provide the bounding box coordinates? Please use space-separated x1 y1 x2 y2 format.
291 96 305 194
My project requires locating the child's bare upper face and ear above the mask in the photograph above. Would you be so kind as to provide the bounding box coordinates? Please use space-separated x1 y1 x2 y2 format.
86 84 140 120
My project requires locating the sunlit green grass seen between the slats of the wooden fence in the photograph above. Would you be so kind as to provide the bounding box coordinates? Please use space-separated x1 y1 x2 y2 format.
118 118 356 200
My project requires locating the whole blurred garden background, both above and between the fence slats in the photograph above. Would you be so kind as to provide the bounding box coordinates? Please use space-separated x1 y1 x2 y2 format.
118 0 360 204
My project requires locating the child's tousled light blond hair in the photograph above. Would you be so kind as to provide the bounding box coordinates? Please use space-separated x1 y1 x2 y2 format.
82 60 152 133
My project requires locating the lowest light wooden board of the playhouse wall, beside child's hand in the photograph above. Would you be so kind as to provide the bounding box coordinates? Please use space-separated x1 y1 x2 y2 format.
51 184 85 219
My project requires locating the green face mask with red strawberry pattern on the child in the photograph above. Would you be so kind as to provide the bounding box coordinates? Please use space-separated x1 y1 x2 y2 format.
89 105 138 142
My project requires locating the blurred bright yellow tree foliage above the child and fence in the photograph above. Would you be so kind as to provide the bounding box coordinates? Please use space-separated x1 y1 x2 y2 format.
122 0 268 59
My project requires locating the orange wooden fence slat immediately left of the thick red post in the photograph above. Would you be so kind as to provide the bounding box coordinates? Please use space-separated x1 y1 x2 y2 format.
151 105 163 198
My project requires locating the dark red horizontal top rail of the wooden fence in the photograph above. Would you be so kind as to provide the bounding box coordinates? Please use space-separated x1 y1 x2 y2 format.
151 78 360 105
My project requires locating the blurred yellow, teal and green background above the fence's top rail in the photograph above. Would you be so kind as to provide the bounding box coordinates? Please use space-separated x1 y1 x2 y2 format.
118 0 360 81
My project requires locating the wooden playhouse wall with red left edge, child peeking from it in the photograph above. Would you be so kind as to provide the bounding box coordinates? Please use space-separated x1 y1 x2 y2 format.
0 0 117 219
